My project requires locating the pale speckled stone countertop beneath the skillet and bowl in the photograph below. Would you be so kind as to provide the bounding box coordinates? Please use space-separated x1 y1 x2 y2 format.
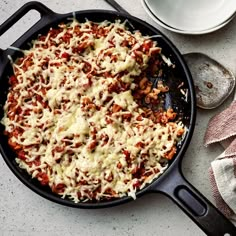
0 0 236 236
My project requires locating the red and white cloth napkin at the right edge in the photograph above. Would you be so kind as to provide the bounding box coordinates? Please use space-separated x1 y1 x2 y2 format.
204 91 236 220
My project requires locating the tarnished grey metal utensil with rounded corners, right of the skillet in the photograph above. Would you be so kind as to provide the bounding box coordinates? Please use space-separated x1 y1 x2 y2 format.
184 53 235 109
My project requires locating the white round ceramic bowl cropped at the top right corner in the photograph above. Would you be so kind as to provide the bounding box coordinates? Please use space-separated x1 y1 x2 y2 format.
142 0 236 34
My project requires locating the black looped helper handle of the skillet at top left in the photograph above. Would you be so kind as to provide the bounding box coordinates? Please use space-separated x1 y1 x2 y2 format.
0 1 54 36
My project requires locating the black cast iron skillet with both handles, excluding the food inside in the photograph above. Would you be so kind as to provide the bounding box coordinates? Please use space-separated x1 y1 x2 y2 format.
0 2 236 236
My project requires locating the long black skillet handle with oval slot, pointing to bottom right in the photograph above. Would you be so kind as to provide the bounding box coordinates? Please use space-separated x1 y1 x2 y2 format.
151 168 236 236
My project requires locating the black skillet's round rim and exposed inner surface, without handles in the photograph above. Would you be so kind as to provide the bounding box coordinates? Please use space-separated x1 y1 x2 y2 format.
0 10 195 208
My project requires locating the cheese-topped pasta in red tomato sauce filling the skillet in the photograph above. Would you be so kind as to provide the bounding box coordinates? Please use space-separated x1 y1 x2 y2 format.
1 19 186 203
